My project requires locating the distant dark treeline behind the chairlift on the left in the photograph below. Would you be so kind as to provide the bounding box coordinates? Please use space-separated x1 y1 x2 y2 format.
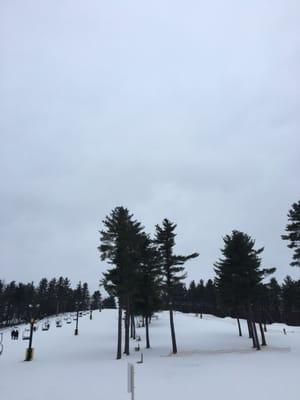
0 277 101 326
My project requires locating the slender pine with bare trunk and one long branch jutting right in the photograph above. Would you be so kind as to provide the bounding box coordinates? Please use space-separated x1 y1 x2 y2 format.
155 218 199 354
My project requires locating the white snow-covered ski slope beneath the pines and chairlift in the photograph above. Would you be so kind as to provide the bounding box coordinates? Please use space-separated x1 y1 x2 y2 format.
0 310 300 400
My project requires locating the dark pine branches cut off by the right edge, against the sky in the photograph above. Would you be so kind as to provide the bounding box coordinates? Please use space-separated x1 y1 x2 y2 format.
281 200 300 267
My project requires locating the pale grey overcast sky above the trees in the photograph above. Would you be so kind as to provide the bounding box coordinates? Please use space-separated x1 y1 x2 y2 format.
0 0 300 290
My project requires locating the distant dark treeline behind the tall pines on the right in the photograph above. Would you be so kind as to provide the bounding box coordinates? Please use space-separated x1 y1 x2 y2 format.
170 276 300 325
